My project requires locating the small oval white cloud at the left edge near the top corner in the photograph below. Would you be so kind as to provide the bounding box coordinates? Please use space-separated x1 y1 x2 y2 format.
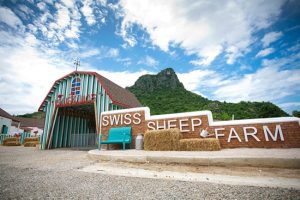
0 7 23 28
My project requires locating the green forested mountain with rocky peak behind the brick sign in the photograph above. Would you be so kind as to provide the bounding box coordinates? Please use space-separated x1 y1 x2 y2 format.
127 68 288 120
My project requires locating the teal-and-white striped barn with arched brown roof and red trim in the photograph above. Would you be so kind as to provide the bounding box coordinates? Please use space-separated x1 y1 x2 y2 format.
39 71 141 149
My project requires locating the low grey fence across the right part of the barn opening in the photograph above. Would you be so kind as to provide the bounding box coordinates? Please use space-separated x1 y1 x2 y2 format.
71 133 97 147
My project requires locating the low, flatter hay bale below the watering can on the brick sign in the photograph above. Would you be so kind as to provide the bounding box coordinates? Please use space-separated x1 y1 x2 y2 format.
179 138 221 151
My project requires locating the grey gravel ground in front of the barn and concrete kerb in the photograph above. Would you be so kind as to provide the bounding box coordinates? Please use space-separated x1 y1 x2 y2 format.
0 146 300 200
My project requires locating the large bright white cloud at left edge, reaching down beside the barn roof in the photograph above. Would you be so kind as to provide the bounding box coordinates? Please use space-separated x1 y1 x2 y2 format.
0 38 72 114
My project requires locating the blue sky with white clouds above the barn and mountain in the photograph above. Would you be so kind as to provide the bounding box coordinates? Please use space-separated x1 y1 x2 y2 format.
0 0 300 114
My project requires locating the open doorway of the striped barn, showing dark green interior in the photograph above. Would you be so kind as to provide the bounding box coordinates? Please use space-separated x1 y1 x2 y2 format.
49 104 97 149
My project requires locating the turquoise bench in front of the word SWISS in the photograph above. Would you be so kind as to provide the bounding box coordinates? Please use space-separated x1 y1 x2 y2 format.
99 127 132 150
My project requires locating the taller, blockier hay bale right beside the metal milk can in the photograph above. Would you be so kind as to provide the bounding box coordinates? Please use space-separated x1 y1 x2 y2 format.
144 129 182 151
